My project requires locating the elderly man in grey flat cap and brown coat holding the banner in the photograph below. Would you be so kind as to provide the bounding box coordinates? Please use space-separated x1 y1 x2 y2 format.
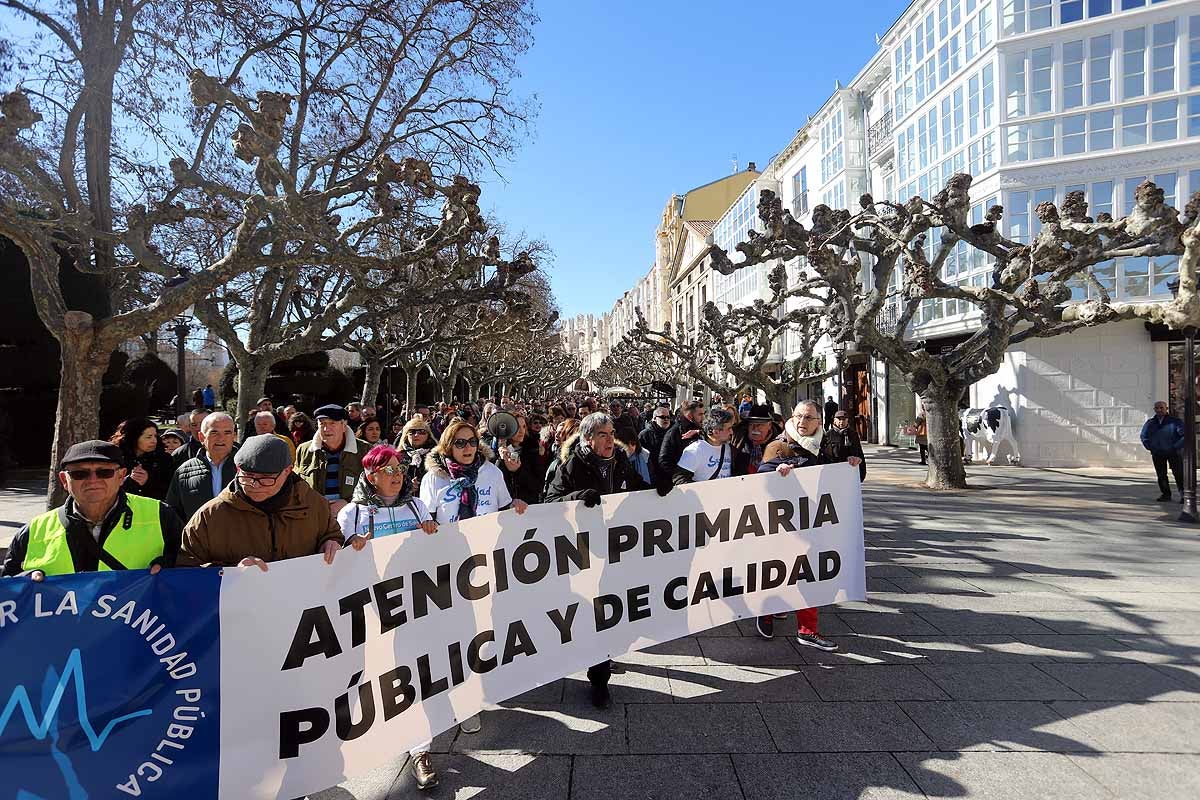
179 433 361 572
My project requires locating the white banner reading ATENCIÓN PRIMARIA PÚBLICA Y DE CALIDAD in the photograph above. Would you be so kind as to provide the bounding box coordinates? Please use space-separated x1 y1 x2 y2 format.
221 464 866 800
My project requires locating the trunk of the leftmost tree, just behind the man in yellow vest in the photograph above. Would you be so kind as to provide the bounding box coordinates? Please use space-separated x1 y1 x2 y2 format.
46 311 109 509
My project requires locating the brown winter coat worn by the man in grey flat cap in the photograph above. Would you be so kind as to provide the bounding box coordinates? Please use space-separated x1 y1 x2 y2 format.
179 480 344 566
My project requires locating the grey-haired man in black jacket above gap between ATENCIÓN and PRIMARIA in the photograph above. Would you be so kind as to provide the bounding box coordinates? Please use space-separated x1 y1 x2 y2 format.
546 411 648 709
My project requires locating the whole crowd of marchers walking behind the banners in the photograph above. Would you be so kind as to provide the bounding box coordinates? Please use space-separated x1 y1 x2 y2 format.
0 390 866 788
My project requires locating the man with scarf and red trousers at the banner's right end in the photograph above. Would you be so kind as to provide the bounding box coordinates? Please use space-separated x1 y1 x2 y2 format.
758 401 863 652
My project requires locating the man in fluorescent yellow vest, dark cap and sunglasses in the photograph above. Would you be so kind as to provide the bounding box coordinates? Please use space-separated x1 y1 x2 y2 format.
0 440 184 581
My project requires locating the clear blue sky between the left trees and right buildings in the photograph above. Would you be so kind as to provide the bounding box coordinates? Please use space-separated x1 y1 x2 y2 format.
482 0 908 317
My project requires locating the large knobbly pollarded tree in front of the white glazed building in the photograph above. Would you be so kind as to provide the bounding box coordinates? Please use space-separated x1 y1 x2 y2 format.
710 174 1200 489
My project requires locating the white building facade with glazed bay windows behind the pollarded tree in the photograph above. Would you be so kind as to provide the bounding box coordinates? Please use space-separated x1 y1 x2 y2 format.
681 0 1200 465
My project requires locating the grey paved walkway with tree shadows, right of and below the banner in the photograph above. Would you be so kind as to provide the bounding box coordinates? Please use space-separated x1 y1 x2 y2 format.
312 450 1200 800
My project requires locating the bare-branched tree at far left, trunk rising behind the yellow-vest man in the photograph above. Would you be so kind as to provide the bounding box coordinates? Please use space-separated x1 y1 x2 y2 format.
0 0 533 504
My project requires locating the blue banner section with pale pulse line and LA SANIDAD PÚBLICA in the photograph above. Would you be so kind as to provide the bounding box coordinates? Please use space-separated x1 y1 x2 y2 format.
0 570 221 800
